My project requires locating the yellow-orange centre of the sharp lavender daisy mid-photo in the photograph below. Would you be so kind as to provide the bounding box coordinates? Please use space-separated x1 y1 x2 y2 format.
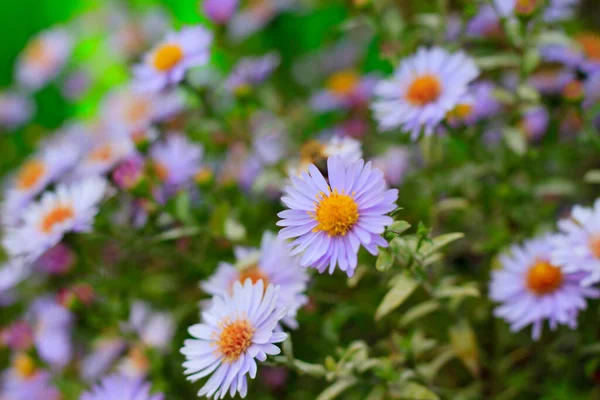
309 189 358 236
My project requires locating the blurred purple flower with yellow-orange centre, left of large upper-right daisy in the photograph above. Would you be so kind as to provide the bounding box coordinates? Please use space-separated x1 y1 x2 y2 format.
310 69 377 111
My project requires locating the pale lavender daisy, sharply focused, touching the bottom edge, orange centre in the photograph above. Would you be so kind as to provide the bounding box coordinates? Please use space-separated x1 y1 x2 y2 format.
181 278 287 399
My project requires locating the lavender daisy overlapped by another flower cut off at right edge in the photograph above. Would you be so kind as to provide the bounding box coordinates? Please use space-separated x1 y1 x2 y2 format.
490 236 600 339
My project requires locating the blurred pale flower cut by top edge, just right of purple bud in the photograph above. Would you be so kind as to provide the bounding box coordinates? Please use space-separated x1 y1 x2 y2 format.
229 0 297 41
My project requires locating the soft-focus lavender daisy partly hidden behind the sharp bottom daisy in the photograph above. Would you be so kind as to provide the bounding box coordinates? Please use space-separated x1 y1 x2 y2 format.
201 232 308 329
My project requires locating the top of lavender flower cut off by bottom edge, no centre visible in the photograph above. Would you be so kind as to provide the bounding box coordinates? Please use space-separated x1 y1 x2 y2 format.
81 375 164 400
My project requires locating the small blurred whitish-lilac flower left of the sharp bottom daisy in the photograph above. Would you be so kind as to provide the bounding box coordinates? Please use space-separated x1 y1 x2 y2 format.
125 301 175 350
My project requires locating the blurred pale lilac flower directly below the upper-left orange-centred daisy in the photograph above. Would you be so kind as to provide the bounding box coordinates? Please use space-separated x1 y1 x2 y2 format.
102 87 184 137
